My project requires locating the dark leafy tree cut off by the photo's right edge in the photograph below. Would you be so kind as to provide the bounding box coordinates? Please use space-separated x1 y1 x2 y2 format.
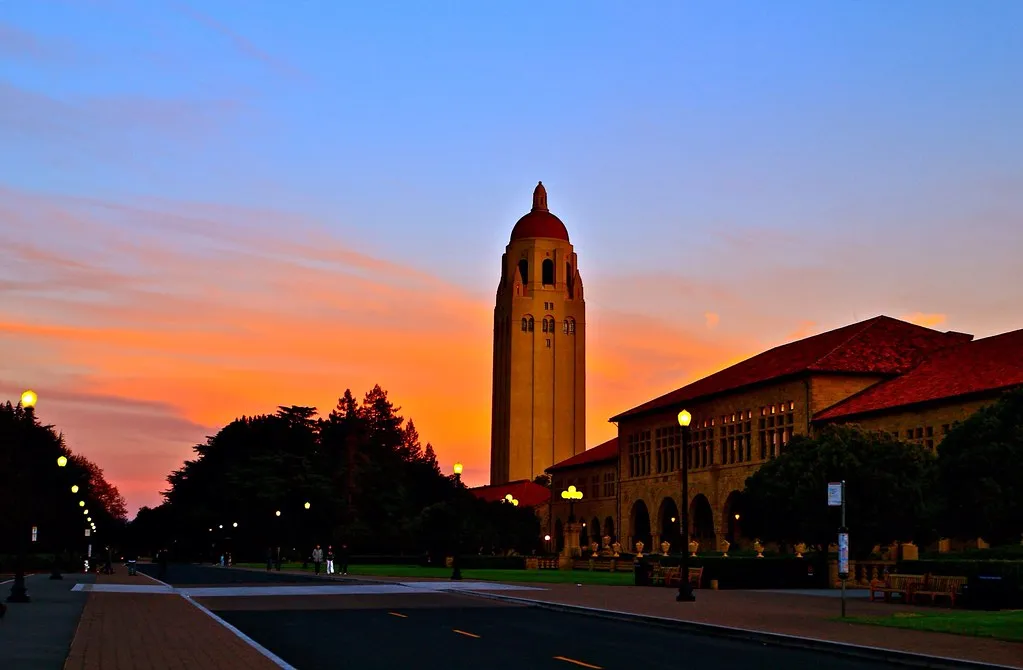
936 389 1023 544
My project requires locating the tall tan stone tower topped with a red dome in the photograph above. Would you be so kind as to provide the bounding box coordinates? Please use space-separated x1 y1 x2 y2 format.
490 182 586 484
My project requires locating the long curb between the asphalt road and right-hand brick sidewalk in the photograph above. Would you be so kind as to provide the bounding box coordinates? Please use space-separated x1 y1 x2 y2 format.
460 589 1019 670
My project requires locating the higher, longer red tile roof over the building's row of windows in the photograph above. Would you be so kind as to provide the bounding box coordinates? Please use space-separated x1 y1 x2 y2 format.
610 316 973 421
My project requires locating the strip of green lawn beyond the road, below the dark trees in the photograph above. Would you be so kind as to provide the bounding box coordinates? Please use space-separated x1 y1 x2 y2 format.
238 563 635 586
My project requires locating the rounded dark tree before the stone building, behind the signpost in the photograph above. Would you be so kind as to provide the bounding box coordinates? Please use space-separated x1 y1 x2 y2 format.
745 426 934 557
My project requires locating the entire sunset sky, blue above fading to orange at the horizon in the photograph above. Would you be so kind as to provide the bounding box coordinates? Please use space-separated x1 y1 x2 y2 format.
0 0 1023 512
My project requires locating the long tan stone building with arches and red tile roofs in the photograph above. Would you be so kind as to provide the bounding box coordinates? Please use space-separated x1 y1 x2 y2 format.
549 316 1023 551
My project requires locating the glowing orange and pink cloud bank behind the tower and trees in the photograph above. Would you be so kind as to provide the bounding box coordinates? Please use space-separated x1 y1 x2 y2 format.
0 189 859 513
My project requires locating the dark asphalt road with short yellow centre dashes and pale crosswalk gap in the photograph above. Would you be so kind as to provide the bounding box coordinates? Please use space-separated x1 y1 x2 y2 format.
138 566 894 670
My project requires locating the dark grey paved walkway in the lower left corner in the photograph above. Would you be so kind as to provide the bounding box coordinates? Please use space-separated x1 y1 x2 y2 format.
0 573 93 670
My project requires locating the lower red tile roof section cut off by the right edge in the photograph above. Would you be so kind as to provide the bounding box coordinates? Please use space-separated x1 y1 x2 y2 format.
813 329 1023 420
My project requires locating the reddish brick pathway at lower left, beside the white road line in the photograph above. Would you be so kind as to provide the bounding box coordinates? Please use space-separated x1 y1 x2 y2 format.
64 567 277 670
